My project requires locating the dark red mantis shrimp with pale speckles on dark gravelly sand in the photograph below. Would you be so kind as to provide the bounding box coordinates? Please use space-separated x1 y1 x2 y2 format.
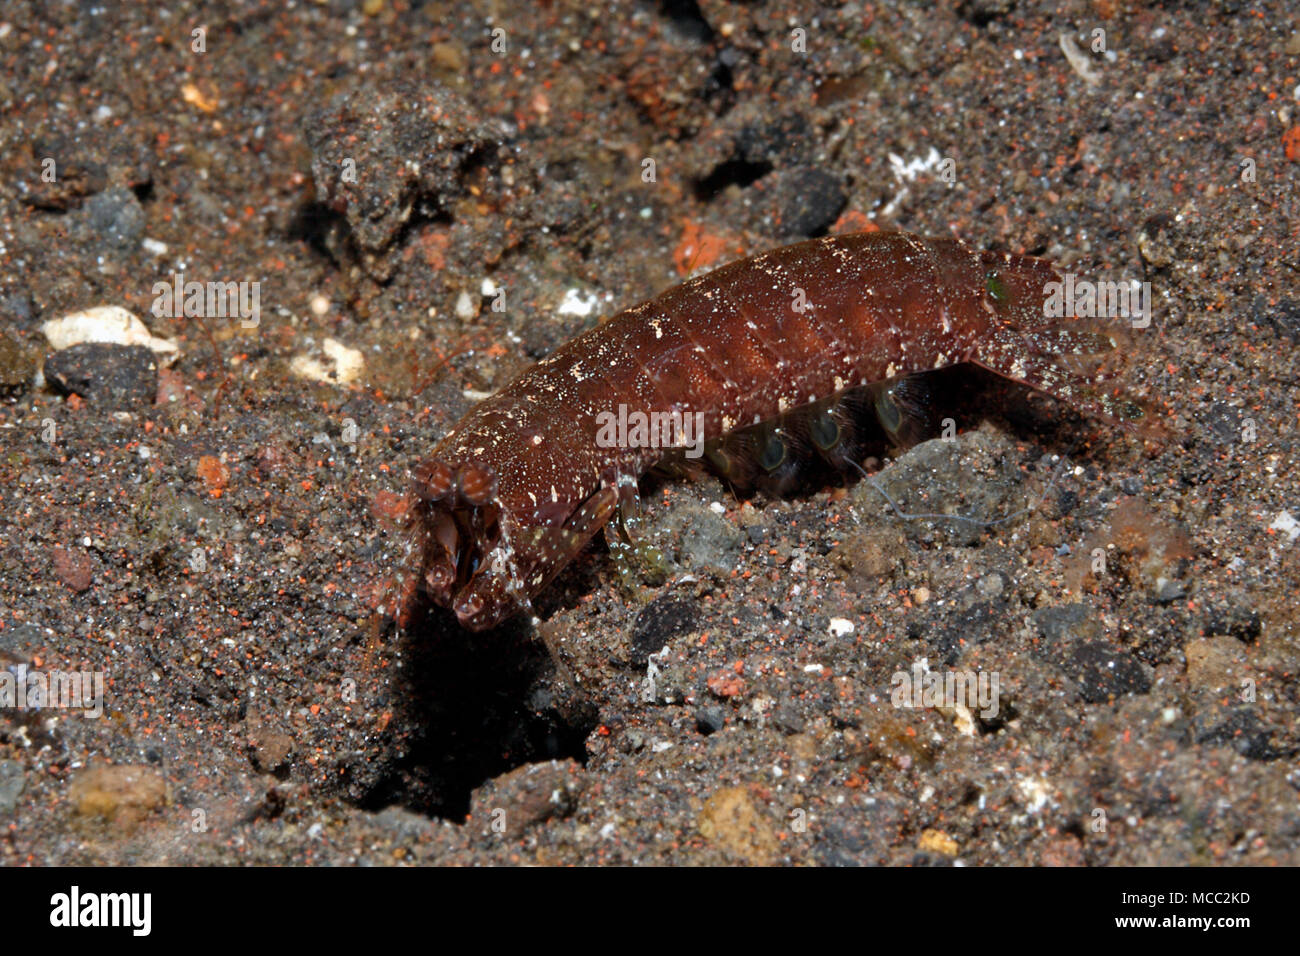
413 233 1128 628
